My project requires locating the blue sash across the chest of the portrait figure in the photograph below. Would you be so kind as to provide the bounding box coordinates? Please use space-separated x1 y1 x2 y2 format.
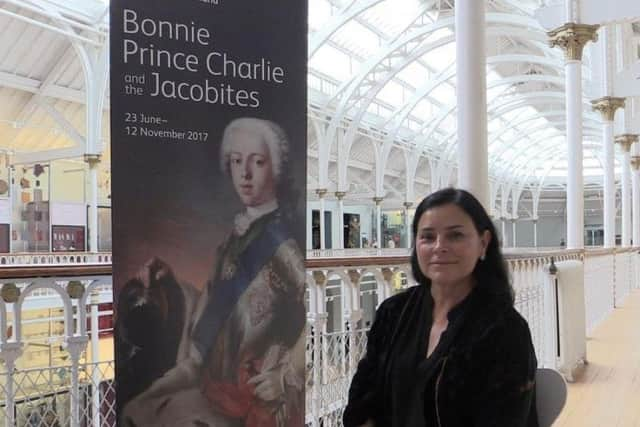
193 219 290 358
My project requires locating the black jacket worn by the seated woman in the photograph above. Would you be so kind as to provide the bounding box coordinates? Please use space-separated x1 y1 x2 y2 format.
343 286 538 427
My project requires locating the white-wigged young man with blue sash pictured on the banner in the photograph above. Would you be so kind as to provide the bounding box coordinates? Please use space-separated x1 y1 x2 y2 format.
124 118 305 427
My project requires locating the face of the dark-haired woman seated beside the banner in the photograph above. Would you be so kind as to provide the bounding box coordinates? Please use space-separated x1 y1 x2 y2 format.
415 203 491 285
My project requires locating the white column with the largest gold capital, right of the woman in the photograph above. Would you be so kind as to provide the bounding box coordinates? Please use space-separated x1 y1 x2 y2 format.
547 22 598 249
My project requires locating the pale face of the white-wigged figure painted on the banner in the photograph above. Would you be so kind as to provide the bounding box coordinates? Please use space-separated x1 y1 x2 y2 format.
229 129 276 206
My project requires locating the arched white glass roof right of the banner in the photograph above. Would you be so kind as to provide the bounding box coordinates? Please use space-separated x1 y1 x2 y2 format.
309 0 602 189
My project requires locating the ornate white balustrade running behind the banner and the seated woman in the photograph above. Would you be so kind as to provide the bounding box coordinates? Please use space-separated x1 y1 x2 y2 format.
0 249 640 427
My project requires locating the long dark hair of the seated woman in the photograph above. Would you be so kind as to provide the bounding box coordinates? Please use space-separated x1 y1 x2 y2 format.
411 188 514 305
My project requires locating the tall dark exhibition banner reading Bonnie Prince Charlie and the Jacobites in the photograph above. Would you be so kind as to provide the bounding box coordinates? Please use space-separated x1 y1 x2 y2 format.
110 0 307 427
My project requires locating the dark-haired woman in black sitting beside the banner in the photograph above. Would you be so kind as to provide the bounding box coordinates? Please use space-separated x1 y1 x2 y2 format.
344 188 538 427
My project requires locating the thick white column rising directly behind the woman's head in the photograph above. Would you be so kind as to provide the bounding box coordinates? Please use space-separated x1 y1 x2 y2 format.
455 0 490 210
